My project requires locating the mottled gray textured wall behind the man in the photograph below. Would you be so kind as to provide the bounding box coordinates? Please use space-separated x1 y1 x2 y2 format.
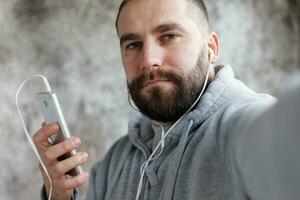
0 0 300 200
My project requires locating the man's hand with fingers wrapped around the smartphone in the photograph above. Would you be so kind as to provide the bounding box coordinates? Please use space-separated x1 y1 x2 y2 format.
33 122 89 200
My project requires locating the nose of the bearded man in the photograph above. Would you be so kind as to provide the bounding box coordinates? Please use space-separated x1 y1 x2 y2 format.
141 42 163 70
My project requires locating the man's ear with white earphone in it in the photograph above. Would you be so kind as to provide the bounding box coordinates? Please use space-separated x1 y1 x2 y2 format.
207 32 219 64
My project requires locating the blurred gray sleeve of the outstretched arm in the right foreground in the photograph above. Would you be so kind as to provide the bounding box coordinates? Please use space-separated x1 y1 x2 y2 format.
233 81 300 200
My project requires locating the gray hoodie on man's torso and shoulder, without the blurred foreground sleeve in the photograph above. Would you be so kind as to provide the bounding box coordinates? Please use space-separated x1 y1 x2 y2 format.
82 66 275 200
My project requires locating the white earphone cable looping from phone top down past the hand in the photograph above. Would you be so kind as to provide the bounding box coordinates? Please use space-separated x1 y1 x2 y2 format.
16 75 52 200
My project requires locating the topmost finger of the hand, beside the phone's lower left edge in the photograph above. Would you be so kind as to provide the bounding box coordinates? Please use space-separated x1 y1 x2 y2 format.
32 123 59 145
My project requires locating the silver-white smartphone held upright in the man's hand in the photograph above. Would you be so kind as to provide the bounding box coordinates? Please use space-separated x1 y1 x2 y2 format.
36 92 82 176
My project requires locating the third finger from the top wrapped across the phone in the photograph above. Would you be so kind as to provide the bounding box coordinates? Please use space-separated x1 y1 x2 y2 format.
53 152 88 177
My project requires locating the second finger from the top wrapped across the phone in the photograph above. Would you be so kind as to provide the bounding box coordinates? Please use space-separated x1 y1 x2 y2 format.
45 137 81 164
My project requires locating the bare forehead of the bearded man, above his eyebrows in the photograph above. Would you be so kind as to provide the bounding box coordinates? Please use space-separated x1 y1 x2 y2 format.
118 0 196 36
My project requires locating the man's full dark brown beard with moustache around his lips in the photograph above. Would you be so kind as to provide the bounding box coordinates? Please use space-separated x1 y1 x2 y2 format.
128 50 209 122
